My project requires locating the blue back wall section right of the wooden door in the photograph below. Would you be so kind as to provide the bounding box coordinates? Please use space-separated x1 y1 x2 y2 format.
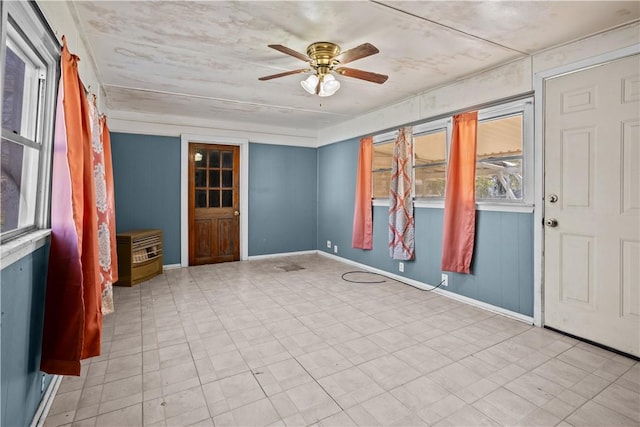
249 144 317 256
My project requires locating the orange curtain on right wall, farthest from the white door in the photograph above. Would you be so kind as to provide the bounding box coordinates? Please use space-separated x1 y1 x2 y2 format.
351 136 373 250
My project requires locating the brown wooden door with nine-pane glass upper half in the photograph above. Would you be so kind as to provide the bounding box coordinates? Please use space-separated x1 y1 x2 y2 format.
189 144 240 265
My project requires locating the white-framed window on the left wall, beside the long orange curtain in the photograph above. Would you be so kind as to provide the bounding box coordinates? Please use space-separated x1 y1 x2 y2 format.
0 2 58 242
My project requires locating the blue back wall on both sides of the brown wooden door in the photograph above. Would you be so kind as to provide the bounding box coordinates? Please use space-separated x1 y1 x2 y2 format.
111 132 317 264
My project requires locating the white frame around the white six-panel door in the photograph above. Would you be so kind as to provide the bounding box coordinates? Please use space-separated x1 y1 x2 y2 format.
533 44 640 326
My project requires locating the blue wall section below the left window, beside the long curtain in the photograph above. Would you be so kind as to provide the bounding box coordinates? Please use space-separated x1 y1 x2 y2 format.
0 245 51 427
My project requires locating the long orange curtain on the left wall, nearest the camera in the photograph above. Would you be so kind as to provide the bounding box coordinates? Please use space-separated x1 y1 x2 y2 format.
40 37 102 375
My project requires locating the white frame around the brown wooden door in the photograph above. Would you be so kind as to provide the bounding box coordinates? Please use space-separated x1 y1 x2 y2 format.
180 134 249 267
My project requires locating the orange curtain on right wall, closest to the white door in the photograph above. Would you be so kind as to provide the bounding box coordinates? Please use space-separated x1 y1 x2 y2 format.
442 111 478 274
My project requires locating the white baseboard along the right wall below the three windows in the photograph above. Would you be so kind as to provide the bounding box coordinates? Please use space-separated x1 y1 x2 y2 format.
317 251 533 325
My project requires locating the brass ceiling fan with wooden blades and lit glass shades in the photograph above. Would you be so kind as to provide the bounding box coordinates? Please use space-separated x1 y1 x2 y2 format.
258 42 389 96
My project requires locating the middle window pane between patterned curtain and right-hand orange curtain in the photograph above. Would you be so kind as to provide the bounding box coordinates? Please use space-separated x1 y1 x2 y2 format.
413 129 447 198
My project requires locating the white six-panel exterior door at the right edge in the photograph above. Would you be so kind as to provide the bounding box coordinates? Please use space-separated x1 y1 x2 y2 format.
544 55 640 356
